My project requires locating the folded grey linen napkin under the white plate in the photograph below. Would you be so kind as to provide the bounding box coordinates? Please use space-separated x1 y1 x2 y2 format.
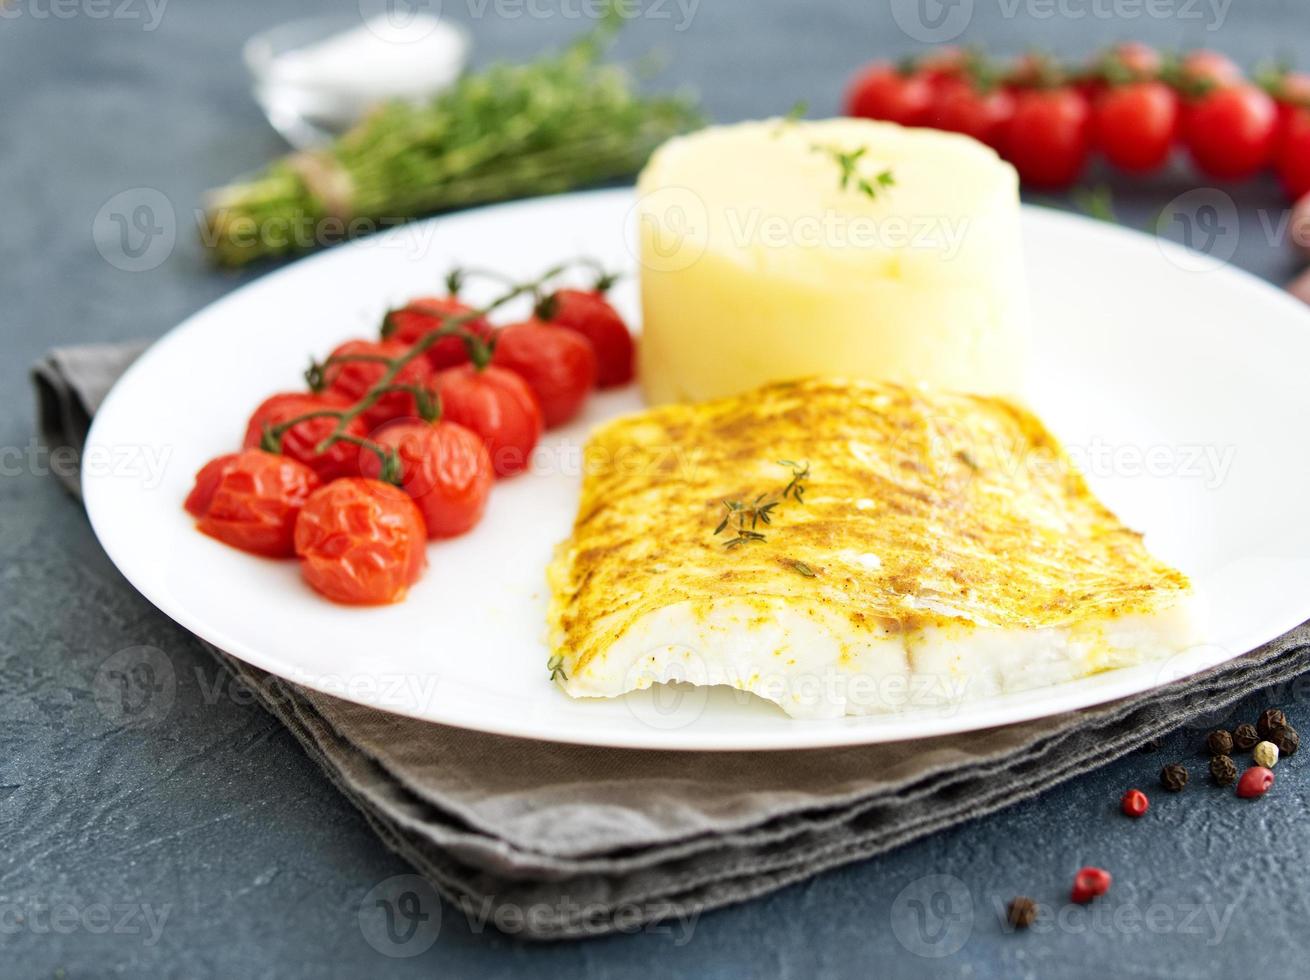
33 346 1310 939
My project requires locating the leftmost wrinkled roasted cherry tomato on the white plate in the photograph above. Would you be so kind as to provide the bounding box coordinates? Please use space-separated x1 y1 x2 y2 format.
186 449 320 558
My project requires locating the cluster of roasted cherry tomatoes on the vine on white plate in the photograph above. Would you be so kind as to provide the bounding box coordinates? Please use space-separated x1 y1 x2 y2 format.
183 270 634 605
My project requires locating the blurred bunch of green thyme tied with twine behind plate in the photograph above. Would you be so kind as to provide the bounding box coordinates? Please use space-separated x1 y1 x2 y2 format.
202 8 700 266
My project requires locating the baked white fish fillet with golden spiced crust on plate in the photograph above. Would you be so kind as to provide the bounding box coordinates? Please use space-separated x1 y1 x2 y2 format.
549 380 1195 718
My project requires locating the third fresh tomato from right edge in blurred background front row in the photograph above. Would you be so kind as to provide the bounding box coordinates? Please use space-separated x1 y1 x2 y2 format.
1094 81 1179 173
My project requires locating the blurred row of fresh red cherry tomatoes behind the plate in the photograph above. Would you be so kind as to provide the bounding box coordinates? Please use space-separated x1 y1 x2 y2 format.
846 43 1310 199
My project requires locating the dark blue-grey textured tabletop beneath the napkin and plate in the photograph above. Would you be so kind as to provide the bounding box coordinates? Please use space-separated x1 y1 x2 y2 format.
0 0 1310 977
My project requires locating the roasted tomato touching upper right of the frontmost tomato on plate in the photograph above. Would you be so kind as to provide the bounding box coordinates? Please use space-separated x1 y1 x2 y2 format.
359 421 495 537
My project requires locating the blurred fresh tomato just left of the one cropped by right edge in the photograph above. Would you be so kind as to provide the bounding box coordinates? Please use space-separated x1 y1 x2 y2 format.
1183 83 1279 181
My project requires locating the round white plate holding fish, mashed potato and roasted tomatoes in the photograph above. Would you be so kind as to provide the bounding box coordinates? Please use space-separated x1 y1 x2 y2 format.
84 191 1310 749
